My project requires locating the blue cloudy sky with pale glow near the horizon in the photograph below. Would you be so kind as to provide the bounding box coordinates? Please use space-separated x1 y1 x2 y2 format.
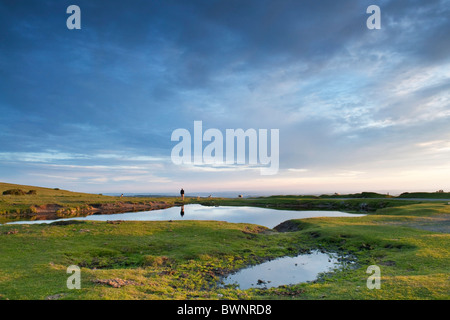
0 0 450 195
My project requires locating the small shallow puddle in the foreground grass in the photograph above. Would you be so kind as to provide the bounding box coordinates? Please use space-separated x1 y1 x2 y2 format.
222 251 343 290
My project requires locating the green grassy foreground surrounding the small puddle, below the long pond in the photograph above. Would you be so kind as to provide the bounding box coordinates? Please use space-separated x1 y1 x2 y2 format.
0 203 450 299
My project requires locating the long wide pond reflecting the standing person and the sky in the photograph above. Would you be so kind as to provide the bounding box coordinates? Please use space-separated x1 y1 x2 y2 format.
3 204 364 228
